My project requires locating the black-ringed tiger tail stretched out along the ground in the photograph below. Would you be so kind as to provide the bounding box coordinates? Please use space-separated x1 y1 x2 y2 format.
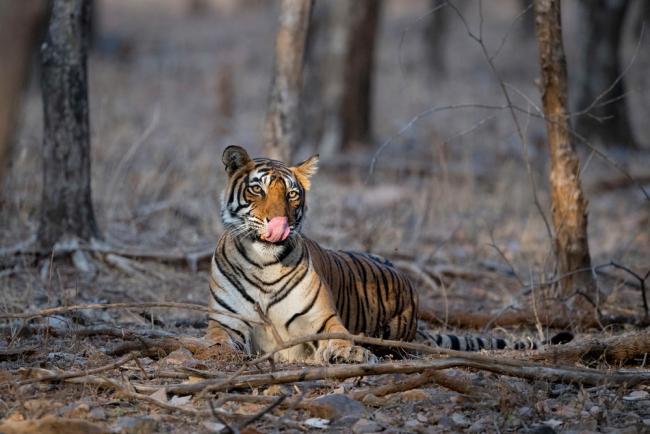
418 329 573 351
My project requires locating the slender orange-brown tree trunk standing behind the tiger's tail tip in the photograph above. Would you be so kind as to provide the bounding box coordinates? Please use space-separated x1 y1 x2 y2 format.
535 0 599 313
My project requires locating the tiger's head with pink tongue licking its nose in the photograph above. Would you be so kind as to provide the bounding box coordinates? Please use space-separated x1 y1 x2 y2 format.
221 146 318 244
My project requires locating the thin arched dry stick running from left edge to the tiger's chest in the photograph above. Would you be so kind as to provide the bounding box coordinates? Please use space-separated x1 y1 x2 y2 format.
0 302 263 324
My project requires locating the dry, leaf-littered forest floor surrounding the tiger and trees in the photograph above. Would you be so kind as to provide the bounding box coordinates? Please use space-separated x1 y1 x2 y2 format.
0 0 650 433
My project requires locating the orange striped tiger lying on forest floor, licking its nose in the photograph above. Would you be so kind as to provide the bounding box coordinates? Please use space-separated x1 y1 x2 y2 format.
206 146 568 363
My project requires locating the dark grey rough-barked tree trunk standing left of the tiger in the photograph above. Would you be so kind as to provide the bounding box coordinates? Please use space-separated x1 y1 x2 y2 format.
38 0 99 247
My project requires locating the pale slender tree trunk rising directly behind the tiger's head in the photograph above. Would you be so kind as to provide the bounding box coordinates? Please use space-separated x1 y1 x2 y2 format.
265 0 312 161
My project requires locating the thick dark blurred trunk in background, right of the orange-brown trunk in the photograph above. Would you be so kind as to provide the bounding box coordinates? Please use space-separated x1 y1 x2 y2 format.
576 0 637 147
